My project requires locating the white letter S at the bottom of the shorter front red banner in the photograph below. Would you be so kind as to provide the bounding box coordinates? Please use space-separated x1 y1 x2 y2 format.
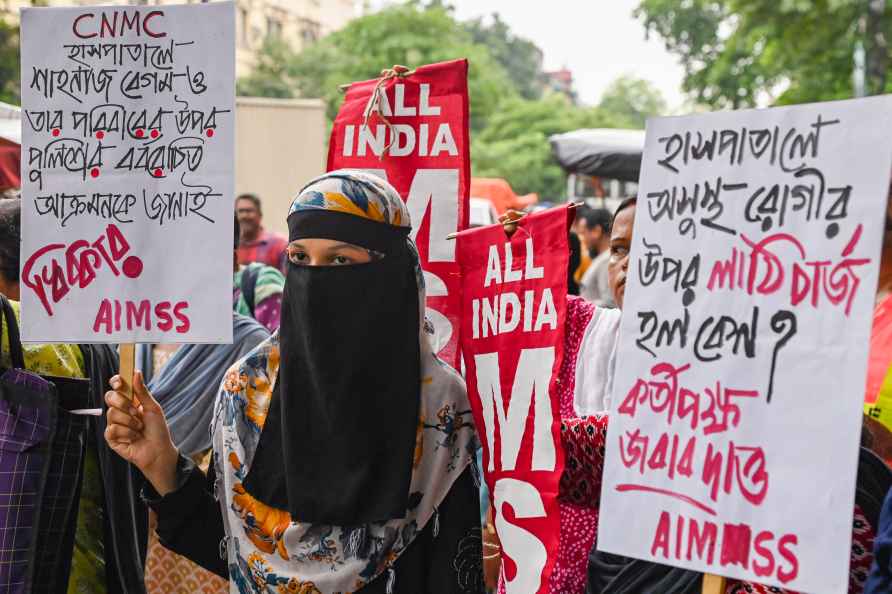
493 476 550 594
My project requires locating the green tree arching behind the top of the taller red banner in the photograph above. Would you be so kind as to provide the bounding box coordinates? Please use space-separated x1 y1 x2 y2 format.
240 3 515 130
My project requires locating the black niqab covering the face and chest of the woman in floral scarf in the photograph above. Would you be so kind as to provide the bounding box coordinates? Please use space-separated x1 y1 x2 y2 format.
244 211 421 526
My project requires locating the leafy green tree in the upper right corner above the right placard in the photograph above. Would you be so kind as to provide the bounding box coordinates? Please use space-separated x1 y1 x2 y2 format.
637 0 892 108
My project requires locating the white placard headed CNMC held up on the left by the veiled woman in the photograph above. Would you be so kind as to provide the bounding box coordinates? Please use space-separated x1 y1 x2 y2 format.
21 2 235 343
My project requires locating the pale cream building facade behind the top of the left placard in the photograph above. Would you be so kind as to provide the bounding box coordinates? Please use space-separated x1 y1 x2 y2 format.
0 0 358 76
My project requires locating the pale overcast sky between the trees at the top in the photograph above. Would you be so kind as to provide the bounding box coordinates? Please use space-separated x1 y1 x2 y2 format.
450 0 684 110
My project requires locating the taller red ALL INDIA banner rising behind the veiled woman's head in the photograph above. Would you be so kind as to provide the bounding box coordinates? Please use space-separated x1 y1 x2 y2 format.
328 60 471 368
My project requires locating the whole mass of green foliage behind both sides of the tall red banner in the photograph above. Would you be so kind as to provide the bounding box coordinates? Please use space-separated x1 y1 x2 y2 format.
239 1 664 200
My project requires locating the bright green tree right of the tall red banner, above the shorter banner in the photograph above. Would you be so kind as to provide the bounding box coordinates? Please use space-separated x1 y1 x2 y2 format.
471 95 612 200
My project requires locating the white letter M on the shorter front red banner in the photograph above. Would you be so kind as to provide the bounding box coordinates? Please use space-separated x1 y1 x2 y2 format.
474 346 556 471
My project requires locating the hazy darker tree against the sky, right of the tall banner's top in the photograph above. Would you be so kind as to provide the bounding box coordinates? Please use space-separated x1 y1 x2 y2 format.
464 12 544 99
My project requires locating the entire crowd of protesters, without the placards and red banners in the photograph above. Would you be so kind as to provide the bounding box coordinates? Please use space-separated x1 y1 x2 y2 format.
0 171 892 594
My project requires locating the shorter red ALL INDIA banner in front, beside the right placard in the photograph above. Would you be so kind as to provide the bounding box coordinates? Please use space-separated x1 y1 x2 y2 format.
458 207 573 594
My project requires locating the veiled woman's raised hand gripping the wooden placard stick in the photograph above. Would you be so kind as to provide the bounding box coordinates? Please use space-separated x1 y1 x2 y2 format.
105 371 179 496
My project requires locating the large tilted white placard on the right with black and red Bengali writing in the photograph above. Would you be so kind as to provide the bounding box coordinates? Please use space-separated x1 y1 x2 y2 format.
598 97 892 593
